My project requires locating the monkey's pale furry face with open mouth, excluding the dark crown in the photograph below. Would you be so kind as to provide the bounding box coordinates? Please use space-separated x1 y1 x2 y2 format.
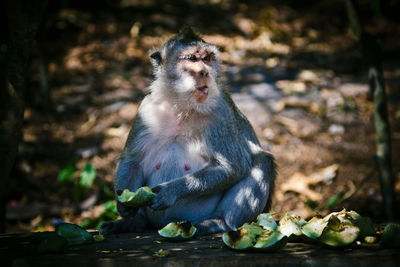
153 43 220 113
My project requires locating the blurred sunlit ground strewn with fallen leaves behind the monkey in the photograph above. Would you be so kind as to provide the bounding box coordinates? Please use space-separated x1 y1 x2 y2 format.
6 0 400 232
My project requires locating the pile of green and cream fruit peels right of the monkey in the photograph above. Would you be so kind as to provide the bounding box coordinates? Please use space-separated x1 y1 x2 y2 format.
222 209 382 251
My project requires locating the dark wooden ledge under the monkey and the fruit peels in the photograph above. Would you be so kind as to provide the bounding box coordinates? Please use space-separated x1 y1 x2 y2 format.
0 232 400 267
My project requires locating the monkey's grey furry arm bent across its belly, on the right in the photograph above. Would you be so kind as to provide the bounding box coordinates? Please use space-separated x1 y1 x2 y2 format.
152 127 251 210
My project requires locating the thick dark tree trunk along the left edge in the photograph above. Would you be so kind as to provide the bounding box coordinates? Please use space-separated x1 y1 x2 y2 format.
0 0 47 232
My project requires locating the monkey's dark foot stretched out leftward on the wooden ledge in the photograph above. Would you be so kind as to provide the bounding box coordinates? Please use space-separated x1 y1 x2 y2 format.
99 208 148 235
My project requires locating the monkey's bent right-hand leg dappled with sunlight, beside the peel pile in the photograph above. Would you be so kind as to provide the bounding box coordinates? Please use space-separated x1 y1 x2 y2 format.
196 152 275 235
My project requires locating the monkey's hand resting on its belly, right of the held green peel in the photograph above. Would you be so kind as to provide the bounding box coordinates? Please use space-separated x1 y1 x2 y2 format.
150 183 178 210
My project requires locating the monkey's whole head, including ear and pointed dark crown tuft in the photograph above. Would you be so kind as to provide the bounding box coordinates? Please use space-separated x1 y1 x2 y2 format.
150 27 220 113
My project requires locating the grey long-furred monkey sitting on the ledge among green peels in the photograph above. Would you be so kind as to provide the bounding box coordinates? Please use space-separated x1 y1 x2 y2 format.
100 26 276 235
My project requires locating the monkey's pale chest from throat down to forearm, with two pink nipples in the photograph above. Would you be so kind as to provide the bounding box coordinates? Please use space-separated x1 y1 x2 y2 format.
140 98 206 187
